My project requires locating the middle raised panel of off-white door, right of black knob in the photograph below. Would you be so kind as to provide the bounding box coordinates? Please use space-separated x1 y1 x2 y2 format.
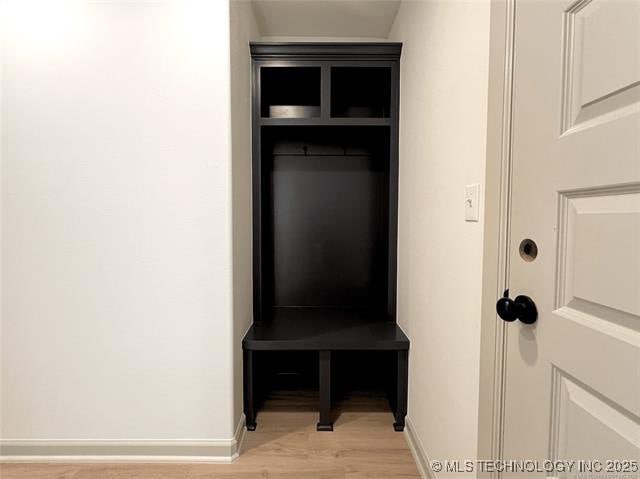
554 183 640 316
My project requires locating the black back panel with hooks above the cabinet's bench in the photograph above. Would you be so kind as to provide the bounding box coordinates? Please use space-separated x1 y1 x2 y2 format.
265 127 389 309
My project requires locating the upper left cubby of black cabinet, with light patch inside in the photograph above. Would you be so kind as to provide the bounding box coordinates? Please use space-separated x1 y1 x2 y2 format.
260 67 321 118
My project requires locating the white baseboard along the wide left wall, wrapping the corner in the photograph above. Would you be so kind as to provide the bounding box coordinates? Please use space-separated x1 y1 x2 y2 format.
0 415 245 463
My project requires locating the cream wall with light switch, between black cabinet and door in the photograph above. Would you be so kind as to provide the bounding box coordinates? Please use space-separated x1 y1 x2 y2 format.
389 0 490 466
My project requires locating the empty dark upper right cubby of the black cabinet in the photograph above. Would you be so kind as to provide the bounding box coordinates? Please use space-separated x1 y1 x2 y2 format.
331 67 391 118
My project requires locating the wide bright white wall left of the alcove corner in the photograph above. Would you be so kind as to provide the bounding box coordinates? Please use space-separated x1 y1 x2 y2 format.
0 1 235 440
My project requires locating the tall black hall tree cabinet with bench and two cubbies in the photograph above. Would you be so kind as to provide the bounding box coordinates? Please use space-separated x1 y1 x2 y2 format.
242 43 409 430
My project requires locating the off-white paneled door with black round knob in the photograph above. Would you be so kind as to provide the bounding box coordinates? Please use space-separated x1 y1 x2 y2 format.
503 0 640 478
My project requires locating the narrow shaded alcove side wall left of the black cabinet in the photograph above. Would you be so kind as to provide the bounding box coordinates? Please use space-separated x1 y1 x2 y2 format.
229 0 260 432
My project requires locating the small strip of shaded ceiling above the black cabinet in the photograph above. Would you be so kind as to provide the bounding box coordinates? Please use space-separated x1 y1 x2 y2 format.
252 0 400 38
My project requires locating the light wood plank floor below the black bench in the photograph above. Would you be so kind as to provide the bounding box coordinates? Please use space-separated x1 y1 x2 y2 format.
0 393 420 479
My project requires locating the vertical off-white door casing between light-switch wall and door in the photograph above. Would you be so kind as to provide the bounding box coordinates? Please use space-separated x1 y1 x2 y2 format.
478 0 517 478
